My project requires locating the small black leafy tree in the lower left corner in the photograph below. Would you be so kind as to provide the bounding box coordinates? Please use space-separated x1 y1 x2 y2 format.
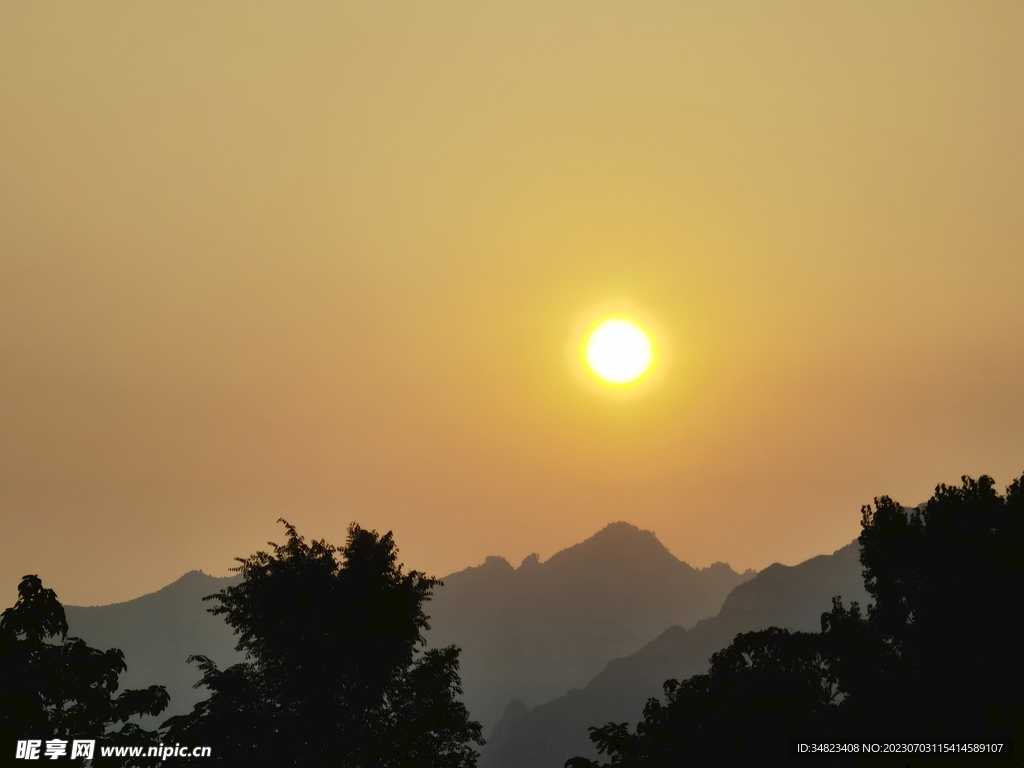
0 575 169 765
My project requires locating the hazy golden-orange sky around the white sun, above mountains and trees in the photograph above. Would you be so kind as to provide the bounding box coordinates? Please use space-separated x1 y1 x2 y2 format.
0 0 1024 607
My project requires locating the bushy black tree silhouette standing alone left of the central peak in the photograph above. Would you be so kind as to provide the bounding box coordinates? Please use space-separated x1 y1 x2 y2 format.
165 520 483 768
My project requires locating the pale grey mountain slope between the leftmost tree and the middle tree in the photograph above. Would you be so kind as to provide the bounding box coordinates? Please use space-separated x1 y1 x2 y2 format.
65 570 242 728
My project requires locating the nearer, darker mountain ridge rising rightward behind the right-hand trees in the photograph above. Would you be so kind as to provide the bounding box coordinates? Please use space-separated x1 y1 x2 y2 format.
479 542 868 768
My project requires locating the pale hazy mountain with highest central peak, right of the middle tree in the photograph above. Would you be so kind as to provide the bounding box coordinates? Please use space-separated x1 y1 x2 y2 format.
427 522 754 731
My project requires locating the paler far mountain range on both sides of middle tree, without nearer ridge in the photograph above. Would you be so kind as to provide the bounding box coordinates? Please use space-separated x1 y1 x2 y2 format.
66 522 753 730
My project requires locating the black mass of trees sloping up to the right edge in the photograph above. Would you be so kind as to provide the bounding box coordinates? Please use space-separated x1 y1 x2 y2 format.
566 476 1024 768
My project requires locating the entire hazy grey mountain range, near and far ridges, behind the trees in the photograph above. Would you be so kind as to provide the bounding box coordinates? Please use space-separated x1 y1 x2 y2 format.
67 522 866 768
